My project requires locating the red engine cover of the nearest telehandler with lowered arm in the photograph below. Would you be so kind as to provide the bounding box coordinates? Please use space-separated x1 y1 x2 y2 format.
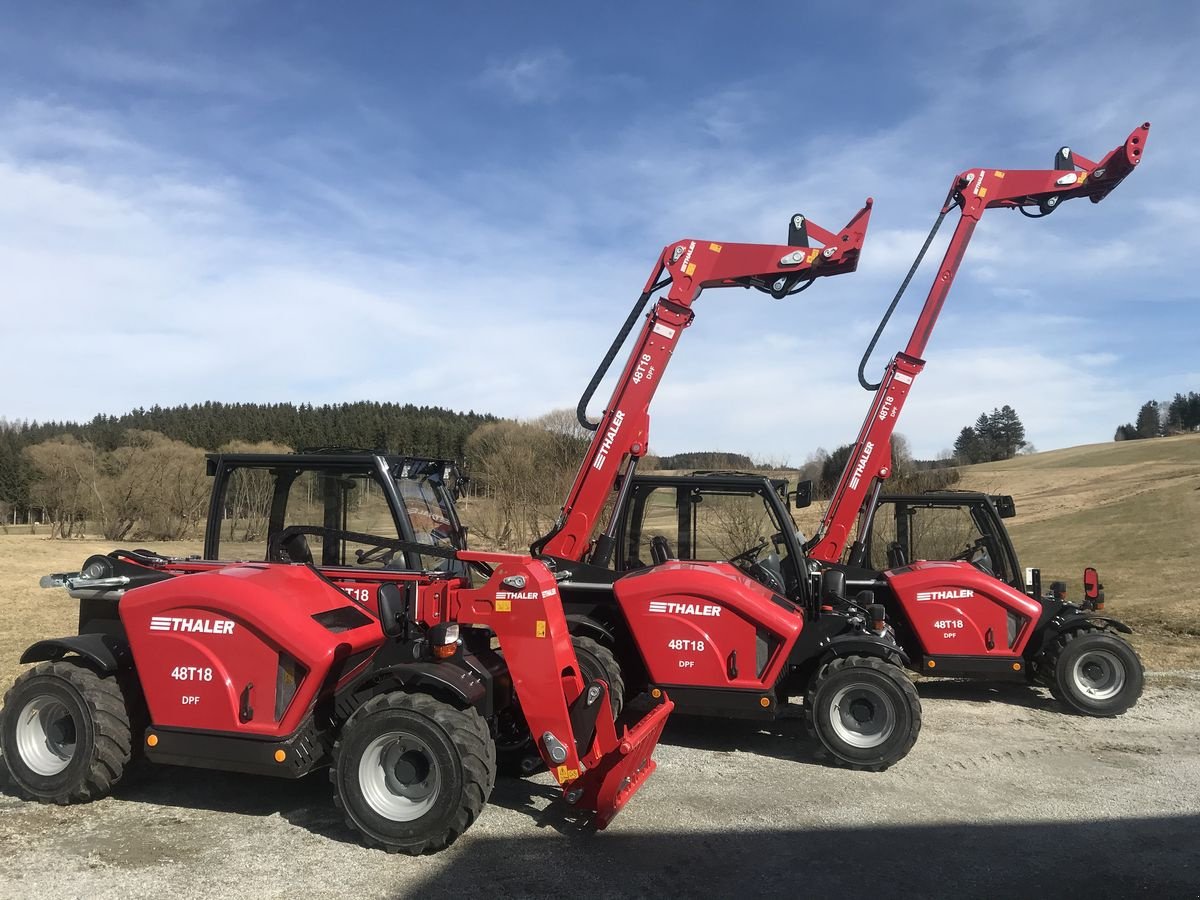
119 563 383 737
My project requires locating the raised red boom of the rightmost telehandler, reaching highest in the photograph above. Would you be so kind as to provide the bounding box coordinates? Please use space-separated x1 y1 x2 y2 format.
808 122 1150 565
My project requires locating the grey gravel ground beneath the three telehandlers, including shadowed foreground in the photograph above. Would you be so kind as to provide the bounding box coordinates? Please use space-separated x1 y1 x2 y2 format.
0 672 1200 900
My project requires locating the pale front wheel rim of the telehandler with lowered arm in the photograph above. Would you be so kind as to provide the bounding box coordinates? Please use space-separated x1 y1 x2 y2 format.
359 732 442 822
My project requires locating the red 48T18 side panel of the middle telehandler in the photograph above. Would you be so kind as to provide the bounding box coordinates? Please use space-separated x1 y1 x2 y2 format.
613 562 804 690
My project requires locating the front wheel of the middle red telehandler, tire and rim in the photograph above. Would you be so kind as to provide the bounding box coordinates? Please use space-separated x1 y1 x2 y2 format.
804 656 920 772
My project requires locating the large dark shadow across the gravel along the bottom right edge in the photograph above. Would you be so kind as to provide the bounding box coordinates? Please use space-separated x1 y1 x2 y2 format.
415 816 1200 900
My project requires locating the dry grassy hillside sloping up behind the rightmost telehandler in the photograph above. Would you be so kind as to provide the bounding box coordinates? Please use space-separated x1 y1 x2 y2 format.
960 434 1200 666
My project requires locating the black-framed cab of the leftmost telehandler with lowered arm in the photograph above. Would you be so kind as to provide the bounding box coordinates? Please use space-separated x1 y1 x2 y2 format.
204 450 467 570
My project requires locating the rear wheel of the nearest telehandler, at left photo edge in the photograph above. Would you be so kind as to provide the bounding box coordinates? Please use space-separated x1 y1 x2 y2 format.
0 659 132 805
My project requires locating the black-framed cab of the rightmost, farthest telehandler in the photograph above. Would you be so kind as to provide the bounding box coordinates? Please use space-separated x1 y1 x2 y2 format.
864 491 1026 593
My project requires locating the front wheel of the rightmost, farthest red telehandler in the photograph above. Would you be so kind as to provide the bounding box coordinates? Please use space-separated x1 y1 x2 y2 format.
1045 628 1145 718
